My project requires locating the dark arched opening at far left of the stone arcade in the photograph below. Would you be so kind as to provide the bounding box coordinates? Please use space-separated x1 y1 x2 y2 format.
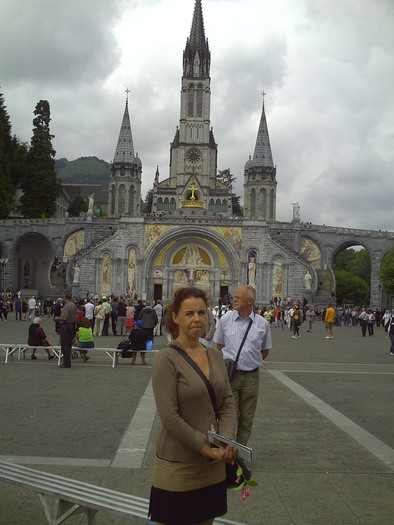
13 233 53 295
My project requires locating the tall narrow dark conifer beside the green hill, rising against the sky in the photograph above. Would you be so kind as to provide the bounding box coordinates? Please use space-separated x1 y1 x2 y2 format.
20 100 62 219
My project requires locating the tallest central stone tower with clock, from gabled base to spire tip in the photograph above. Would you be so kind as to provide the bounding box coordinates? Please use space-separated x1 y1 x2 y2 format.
152 0 232 216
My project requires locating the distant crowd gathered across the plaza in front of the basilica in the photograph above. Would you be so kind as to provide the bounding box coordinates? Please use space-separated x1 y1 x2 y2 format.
0 292 392 345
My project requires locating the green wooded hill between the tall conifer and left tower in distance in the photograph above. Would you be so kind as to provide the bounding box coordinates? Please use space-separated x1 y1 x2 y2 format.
55 157 109 185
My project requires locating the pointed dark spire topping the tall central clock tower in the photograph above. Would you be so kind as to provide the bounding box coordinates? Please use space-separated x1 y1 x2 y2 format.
183 0 211 78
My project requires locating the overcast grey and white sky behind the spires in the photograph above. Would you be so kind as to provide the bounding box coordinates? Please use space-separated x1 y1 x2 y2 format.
0 0 394 230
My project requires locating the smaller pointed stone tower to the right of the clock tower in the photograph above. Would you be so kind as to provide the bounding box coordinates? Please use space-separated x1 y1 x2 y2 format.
244 103 277 221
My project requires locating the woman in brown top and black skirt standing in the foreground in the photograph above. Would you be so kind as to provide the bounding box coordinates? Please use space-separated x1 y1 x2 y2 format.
149 288 237 525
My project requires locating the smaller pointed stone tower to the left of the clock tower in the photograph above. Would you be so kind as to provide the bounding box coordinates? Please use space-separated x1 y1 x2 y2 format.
108 94 142 216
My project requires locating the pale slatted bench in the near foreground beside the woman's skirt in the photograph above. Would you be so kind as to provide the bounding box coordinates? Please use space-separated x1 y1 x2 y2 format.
0 461 243 525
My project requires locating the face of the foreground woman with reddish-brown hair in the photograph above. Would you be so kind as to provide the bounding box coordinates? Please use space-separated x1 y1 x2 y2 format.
172 297 207 338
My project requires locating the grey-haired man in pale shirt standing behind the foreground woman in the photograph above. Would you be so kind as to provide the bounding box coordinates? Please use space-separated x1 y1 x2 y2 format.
213 286 272 445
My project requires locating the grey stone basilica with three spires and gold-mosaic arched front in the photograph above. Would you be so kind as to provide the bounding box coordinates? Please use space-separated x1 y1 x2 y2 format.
0 0 394 307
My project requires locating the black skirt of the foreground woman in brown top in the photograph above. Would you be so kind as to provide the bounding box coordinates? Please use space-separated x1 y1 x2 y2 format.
149 480 227 525
